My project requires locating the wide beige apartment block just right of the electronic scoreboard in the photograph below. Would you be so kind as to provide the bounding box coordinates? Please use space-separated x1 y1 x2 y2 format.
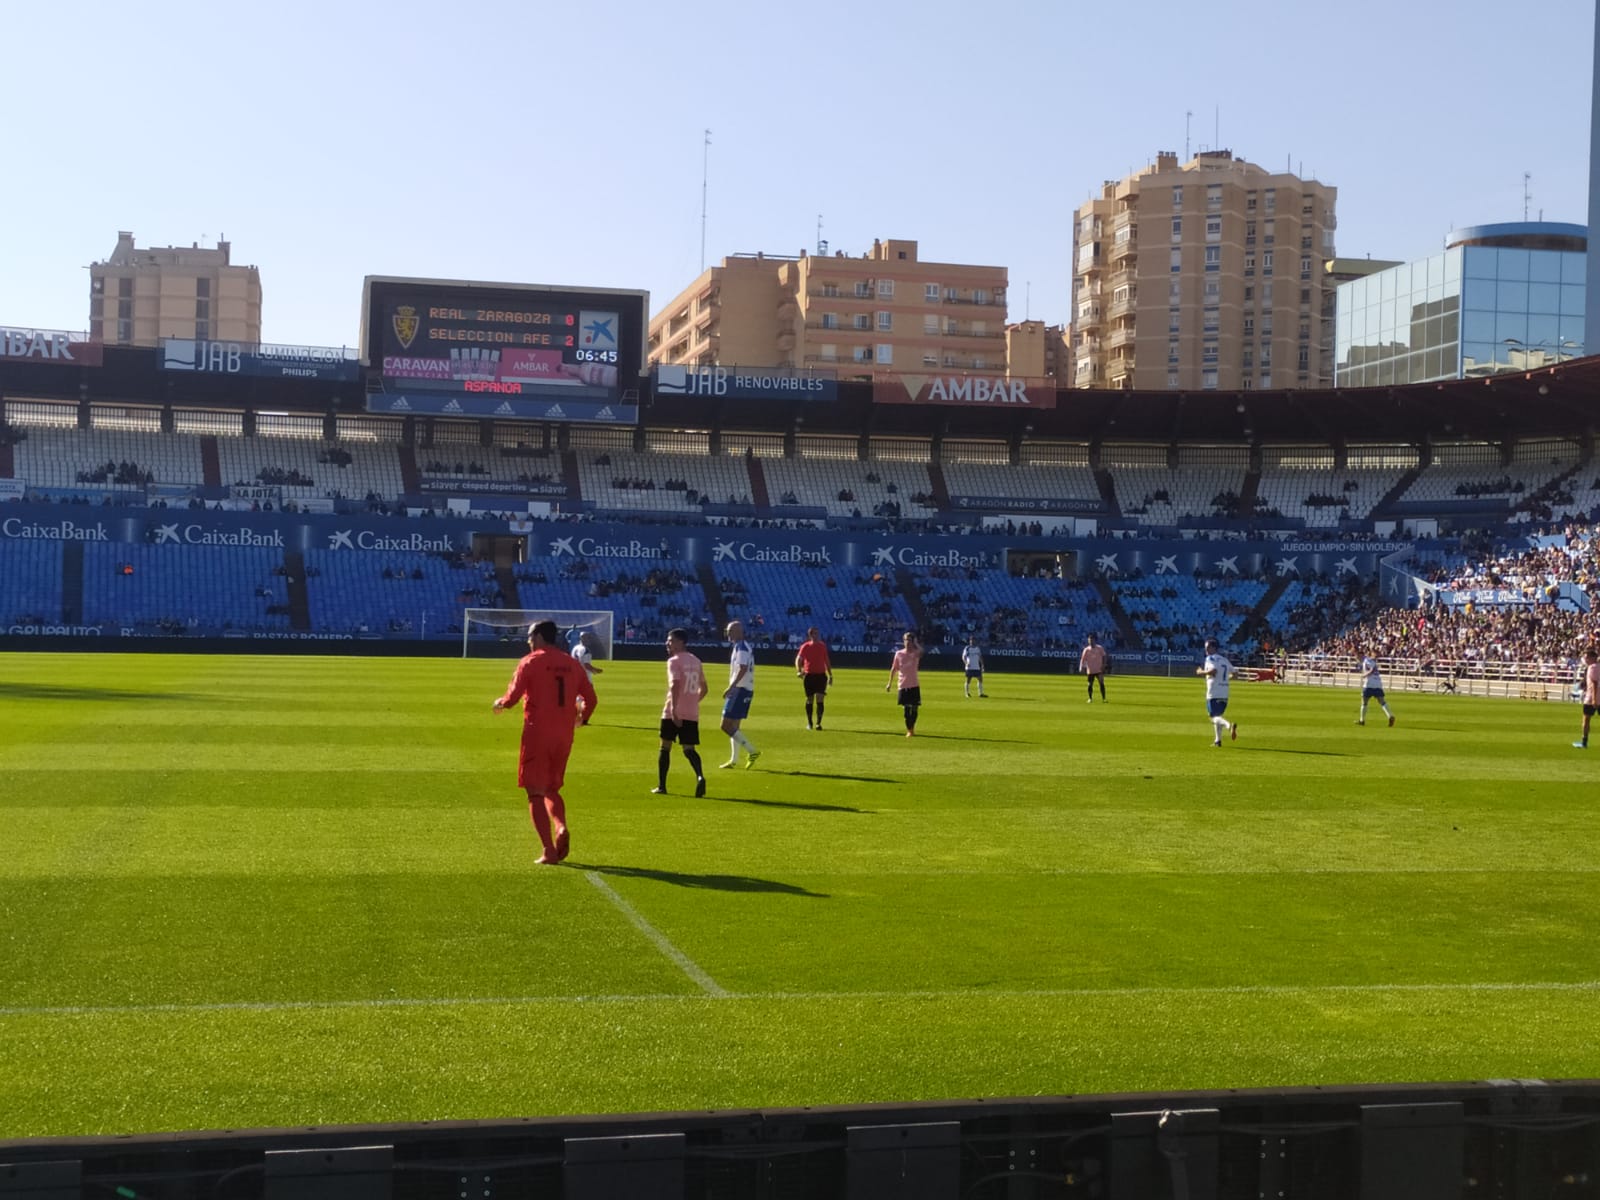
650 238 1006 379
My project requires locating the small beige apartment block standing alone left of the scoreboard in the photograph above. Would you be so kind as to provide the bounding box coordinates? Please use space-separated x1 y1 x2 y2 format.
90 230 261 346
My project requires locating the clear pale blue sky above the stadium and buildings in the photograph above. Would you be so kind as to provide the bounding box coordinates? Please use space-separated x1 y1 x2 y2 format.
0 0 1594 346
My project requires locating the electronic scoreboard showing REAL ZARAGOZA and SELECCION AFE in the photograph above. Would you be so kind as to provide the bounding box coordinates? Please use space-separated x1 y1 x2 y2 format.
362 275 650 424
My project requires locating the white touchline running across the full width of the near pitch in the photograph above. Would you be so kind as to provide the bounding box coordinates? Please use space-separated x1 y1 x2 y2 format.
0 979 1600 1019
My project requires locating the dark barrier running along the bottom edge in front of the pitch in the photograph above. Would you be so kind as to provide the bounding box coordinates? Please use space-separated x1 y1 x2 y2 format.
0 1080 1600 1200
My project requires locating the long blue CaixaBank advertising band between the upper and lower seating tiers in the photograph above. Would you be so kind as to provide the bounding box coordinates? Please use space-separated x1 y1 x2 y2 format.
0 501 1408 581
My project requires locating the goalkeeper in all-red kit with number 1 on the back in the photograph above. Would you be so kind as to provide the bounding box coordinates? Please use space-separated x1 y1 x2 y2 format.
494 621 600 866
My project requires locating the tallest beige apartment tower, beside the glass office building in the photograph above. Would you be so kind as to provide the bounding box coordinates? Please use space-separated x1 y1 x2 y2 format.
1072 150 1338 390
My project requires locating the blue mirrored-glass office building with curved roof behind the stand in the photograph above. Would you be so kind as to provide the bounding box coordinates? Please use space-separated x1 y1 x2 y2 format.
1334 221 1587 387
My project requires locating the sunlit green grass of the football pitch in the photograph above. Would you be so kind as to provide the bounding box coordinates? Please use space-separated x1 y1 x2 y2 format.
0 654 1600 1138
